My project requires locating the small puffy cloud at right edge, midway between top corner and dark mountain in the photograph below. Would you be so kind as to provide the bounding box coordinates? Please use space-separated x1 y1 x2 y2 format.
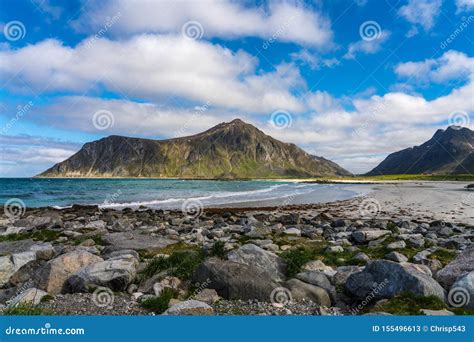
395 50 474 83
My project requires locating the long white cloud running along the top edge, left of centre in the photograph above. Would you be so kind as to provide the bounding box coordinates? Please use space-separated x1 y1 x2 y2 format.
74 0 333 47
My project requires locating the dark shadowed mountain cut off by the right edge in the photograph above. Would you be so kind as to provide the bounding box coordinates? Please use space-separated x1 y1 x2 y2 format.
367 126 474 176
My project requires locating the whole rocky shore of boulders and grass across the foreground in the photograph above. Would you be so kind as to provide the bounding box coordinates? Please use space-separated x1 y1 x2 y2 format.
0 198 474 315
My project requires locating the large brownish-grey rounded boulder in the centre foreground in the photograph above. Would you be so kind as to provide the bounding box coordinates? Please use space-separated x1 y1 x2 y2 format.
192 258 279 302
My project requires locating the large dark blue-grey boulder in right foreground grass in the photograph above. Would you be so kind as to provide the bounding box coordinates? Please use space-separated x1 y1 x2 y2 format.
345 260 445 300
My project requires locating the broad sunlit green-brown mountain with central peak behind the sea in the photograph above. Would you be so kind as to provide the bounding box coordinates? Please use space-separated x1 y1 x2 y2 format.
38 119 350 179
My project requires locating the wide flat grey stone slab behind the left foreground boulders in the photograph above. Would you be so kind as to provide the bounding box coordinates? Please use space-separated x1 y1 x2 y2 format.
104 231 177 254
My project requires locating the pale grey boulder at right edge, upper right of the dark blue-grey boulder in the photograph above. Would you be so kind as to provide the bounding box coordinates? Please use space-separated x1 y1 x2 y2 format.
435 244 474 288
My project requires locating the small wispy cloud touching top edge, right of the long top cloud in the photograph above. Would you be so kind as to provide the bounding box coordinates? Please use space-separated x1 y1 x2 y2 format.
398 0 442 36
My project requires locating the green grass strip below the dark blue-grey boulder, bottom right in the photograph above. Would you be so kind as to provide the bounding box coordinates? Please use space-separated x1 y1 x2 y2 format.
368 292 474 315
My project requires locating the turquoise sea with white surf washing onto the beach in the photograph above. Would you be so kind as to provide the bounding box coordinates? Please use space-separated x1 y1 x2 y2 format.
0 178 369 209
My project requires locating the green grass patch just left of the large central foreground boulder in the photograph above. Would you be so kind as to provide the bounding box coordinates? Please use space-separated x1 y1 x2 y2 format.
142 251 204 279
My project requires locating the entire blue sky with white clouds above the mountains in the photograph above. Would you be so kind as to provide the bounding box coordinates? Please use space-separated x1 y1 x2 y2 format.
0 0 474 177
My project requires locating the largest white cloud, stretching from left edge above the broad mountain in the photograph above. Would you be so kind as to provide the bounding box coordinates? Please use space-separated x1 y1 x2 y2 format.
0 35 305 112
